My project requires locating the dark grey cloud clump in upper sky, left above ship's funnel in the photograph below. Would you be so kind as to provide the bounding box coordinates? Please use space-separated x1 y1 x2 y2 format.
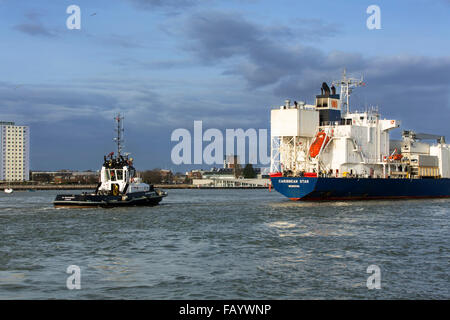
181 12 342 88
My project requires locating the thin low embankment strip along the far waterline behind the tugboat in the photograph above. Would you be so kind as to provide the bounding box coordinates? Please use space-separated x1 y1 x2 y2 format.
0 184 268 191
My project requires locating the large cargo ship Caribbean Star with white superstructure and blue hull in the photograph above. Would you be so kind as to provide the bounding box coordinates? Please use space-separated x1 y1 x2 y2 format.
270 70 450 201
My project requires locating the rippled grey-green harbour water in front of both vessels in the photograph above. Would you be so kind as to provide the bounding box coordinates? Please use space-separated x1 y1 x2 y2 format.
0 189 450 299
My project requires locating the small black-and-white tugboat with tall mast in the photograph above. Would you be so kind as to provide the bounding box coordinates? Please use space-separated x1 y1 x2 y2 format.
53 114 167 208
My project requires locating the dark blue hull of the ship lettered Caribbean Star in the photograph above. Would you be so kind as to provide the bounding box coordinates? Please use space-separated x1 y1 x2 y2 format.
270 177 450 201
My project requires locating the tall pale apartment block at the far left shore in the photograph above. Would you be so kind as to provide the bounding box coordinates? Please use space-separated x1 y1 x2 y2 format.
0 122 30 181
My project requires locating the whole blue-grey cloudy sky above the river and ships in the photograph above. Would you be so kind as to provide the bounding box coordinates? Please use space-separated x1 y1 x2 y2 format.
0 0 450 172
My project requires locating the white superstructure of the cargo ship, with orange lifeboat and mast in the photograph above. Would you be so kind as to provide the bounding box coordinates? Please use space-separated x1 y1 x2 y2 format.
271 72 450 178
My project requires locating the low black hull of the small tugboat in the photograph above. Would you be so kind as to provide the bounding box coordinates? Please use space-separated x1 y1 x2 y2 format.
53 191 167 208
